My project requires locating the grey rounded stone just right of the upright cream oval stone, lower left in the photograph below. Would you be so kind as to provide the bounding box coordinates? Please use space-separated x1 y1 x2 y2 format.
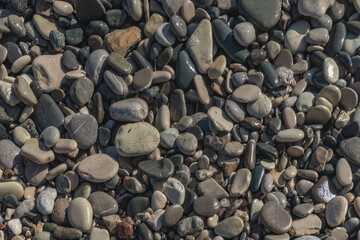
87 191 119 218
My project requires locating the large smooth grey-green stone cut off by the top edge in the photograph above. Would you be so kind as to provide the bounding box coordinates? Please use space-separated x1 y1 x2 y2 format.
238 0 282 31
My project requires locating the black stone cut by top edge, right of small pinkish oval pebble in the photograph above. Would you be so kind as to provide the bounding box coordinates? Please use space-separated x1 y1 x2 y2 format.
75 0 105 24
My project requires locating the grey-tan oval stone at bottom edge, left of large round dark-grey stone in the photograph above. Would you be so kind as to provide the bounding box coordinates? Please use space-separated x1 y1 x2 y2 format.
214 217 244 238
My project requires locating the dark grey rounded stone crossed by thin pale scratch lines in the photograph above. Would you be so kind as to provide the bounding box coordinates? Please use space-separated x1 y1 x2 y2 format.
65 113 98 149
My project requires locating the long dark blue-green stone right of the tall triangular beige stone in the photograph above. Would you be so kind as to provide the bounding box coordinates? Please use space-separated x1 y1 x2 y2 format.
212 19 250 63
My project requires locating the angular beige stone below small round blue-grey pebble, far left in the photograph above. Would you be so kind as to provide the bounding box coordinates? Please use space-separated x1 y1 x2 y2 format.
20 138 55 164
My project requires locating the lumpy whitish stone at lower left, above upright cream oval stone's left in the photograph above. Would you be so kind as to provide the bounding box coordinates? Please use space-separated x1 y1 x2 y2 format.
36 187 57 215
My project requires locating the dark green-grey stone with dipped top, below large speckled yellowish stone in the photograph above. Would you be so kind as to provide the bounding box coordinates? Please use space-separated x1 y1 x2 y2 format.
138 158 174 180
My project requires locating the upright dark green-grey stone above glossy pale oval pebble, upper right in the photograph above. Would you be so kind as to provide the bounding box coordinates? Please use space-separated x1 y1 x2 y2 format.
325 22 346 56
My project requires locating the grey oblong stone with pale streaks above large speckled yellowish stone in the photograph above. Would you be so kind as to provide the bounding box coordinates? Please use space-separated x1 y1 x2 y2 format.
109 98 149 122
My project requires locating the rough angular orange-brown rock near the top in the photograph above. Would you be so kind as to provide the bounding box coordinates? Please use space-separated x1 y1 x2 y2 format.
104 26 141 57
